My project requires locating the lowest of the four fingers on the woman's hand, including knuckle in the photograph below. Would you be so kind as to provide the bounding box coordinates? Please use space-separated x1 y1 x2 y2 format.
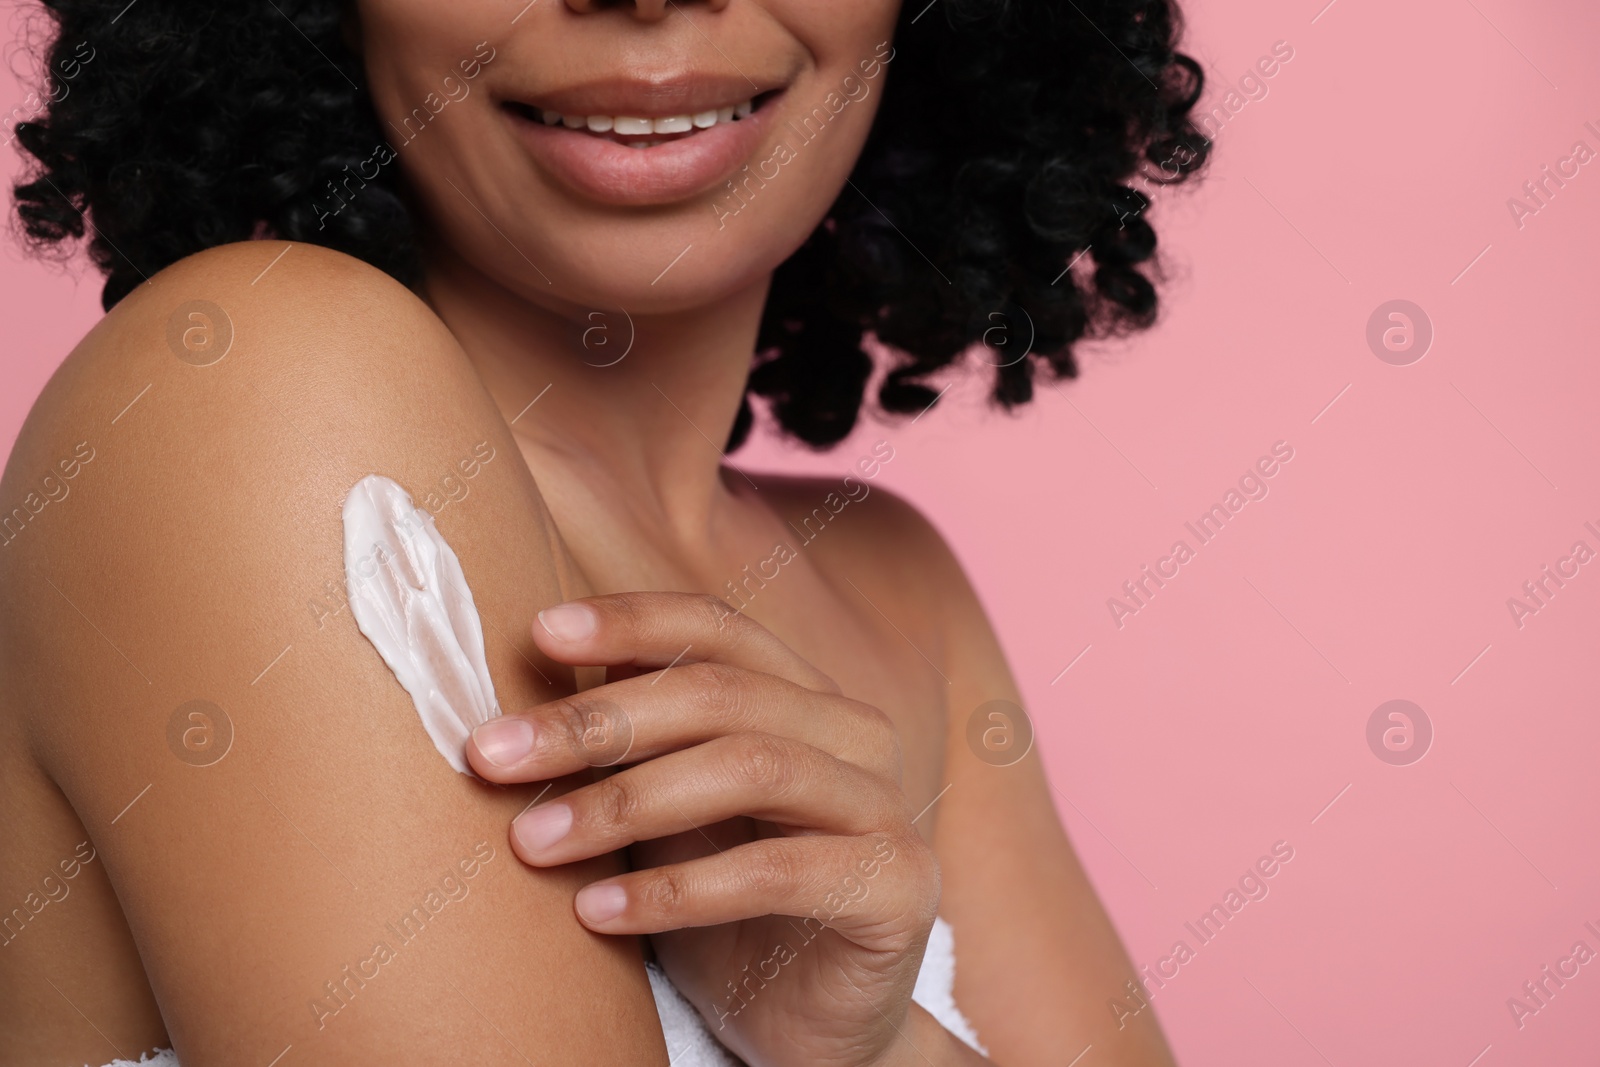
574 833 939 952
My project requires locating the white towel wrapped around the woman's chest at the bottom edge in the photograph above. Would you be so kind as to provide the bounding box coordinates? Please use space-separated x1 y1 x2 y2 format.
93 918 987 1067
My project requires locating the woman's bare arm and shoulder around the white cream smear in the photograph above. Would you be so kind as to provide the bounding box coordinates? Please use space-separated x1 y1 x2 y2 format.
0 242 666 1067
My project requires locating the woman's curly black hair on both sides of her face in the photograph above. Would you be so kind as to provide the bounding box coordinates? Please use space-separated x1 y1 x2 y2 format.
13 0 1211 451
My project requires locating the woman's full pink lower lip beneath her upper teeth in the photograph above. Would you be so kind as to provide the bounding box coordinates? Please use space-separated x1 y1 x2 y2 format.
504 93 781 206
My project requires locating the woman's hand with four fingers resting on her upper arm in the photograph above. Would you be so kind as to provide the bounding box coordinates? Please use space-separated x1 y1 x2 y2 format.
467 593 939 1067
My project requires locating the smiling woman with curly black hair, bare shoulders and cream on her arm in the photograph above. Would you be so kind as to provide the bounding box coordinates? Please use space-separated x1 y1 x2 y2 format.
0 0 1206 1067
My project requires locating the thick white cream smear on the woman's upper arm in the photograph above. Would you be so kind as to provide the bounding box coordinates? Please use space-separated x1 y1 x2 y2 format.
344 474 501 774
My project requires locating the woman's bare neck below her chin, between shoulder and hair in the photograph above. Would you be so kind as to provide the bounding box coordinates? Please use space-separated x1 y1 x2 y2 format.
421 235 771 547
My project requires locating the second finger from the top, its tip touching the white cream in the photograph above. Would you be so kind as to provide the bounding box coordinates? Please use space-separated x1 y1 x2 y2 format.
467 662 901 782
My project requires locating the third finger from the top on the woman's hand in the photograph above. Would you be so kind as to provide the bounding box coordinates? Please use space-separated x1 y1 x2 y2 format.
512 733 910 867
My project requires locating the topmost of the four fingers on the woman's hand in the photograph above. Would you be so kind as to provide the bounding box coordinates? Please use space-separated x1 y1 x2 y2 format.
533 592 840 693
